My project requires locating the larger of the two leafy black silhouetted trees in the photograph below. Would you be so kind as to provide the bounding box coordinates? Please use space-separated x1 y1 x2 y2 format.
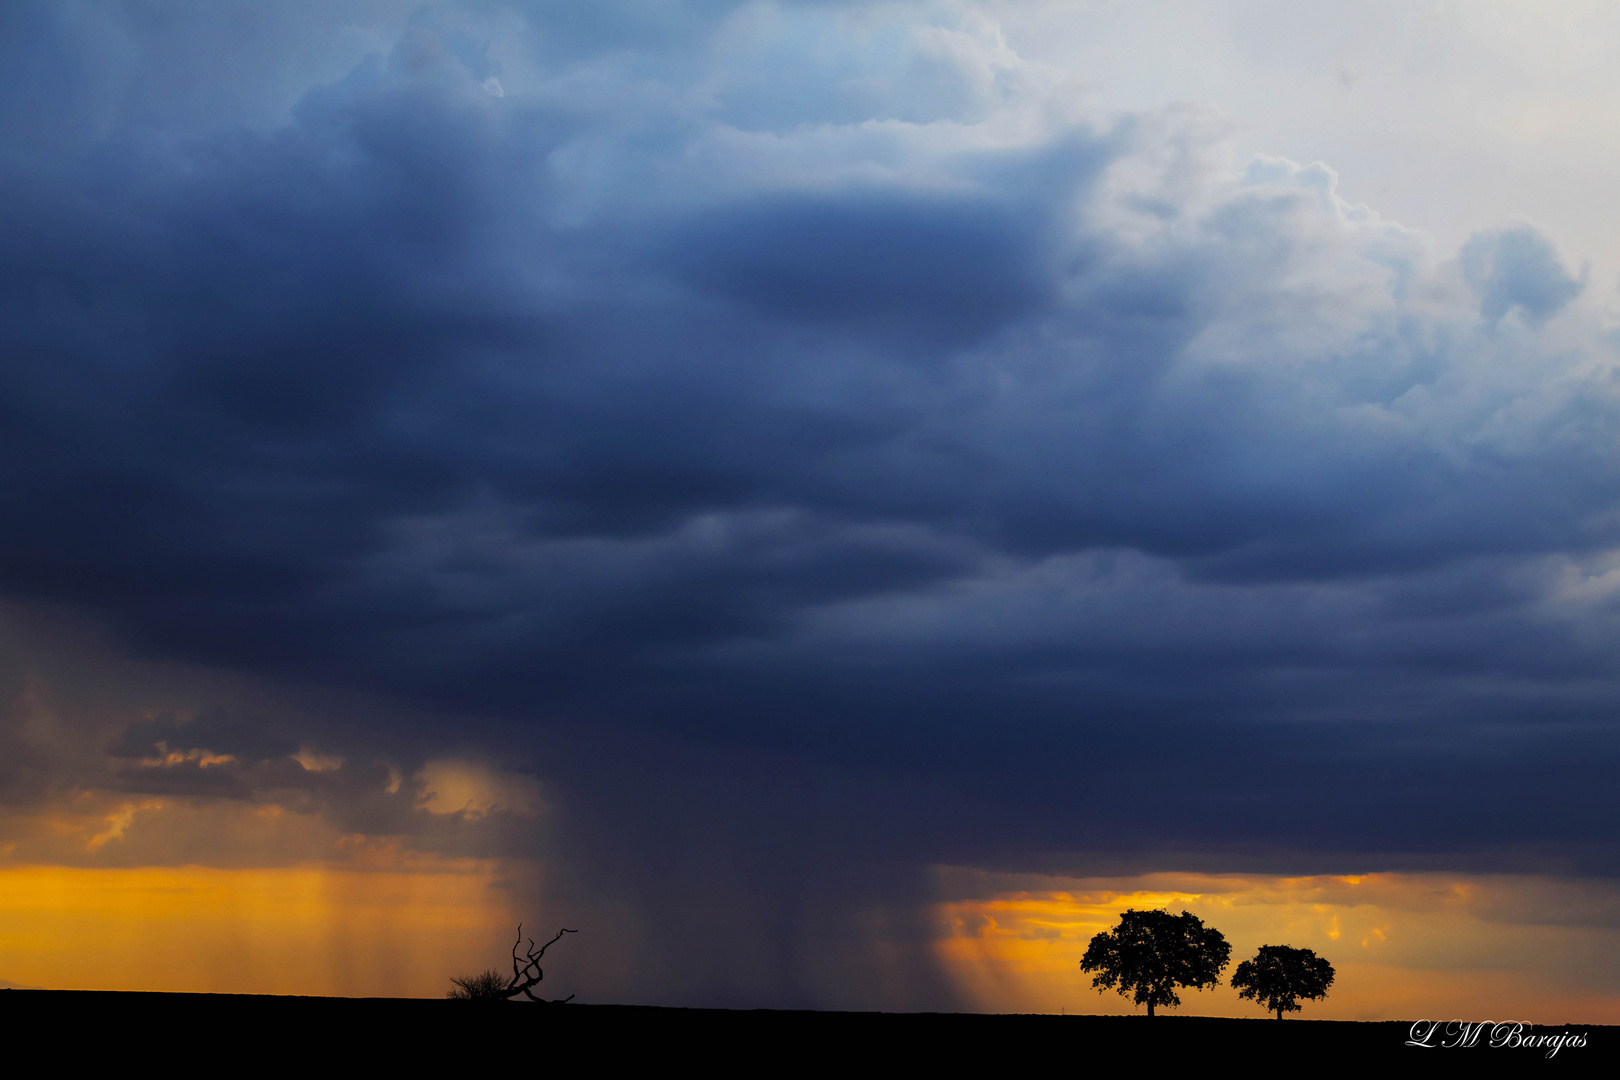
1081 910 1231 1015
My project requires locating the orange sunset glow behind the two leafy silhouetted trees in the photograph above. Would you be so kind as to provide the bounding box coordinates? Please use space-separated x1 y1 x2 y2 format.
938 870 1620 1023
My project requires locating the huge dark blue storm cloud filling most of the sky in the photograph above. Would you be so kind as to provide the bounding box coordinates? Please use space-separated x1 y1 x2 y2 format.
0 5 1620 994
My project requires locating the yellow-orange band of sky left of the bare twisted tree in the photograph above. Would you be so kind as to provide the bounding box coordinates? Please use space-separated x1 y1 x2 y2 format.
0 858 522 997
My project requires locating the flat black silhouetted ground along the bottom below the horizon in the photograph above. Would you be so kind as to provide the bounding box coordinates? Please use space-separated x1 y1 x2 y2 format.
0 989 1620 1080
